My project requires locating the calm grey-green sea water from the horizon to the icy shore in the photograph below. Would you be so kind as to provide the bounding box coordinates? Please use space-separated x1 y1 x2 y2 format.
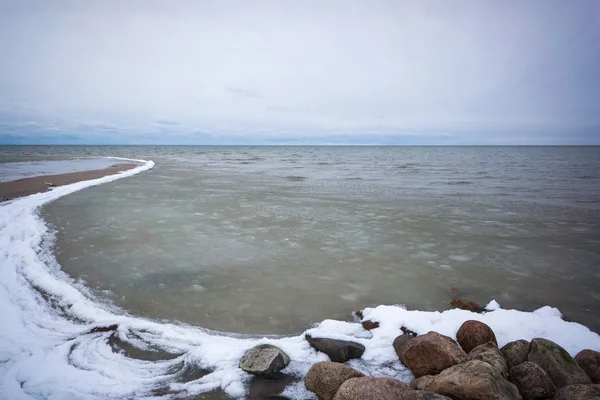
0 146 600 333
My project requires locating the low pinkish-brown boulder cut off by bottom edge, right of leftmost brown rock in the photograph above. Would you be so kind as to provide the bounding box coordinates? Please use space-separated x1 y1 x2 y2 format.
334 376 408 400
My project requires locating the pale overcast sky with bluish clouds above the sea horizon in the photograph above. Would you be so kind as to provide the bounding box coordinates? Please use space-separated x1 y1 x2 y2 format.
0 0 600 145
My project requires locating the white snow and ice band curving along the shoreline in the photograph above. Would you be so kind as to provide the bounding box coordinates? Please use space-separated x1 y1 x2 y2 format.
0 160 600 399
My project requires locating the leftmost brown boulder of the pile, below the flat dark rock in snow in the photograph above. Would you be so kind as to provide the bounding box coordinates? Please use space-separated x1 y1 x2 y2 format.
304 362 364 400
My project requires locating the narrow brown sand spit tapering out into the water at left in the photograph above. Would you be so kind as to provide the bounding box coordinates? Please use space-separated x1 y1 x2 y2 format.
0 164 139 201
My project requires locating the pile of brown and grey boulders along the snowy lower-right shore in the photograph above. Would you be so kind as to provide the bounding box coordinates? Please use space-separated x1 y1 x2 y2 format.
304 321 600 400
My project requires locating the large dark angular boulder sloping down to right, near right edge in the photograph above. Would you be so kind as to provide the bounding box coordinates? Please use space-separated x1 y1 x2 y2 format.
527 338 592 389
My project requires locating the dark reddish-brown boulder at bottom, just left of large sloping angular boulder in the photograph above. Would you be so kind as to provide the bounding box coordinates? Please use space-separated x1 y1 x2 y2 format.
508 361 556 400
